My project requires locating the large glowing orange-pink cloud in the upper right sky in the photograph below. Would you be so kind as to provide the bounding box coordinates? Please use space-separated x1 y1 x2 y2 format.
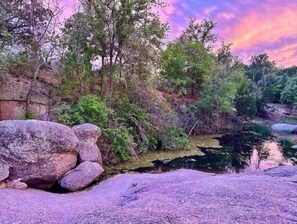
224 5 297 49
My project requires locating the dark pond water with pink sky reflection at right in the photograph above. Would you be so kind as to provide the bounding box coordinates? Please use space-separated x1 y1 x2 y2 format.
133 132 297 173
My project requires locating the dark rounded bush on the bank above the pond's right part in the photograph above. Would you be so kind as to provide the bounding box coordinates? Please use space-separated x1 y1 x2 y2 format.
235 96 257 118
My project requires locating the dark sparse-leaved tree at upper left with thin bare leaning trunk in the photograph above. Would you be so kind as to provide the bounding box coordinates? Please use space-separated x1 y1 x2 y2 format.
0 0 61 113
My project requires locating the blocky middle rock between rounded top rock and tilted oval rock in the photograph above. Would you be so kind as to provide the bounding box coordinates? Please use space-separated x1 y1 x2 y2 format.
79 142 103 166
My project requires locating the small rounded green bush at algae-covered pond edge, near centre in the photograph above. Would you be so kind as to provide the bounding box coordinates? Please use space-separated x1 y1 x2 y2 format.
160 127 189 150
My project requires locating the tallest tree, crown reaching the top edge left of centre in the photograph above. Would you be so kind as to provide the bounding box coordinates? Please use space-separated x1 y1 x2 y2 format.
81 0 165 93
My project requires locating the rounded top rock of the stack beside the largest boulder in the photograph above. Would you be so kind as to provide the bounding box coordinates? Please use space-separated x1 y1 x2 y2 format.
73 124 101 143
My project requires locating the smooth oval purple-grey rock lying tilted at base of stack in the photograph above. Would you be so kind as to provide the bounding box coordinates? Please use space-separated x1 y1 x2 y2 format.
59 162 104 191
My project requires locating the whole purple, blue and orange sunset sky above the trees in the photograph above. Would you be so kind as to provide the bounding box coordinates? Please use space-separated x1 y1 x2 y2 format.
62 0 297 67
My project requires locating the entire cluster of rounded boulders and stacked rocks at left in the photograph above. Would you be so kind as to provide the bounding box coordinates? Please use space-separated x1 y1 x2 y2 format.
0 120 103 191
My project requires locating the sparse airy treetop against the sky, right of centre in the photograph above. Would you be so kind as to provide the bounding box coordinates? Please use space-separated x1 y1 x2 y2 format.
178 18 218 49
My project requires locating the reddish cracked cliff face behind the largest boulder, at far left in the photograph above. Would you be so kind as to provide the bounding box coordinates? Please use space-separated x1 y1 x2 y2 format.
0 69 59 120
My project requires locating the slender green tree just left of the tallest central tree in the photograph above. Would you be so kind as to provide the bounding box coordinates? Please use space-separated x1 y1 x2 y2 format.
60 13 94 97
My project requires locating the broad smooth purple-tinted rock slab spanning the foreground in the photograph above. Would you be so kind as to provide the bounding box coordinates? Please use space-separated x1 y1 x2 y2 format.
0 167 297 224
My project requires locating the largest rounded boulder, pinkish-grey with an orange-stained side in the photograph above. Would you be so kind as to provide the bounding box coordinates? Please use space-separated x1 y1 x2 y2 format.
0 120 79 189
